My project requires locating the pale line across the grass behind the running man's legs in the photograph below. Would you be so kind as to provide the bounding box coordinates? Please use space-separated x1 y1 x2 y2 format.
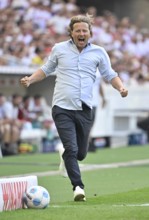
1 159 149 178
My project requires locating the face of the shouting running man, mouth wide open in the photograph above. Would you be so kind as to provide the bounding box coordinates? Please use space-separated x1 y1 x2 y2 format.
71 22 91 51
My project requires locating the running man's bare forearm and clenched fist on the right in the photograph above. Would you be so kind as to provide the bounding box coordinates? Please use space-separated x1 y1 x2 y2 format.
111 76 128 97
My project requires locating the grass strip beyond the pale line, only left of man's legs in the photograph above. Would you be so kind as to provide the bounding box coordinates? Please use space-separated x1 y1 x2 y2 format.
0 153 59 177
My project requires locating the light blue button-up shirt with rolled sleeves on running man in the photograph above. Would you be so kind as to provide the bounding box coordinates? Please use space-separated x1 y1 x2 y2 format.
41 40 117 110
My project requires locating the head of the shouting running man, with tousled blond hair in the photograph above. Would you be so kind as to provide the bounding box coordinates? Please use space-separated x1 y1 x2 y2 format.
68 15 93 51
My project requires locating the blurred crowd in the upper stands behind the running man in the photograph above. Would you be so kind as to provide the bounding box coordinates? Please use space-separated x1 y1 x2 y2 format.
0 0 149 84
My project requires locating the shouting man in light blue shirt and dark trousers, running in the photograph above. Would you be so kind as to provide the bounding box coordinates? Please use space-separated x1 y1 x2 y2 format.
21 15 128 201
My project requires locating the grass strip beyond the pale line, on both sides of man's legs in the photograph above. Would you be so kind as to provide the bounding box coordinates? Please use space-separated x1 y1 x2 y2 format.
0 146 149 177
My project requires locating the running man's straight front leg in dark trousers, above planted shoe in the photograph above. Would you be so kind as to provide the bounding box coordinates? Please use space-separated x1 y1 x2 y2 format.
52 106 84 189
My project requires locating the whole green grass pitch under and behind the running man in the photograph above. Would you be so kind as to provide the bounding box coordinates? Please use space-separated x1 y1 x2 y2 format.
0 146 149 220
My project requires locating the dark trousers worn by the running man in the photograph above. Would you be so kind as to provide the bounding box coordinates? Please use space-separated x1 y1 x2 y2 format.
52 104 92 189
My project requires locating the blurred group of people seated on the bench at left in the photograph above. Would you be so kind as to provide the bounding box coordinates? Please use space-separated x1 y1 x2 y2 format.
0 93 56 155
